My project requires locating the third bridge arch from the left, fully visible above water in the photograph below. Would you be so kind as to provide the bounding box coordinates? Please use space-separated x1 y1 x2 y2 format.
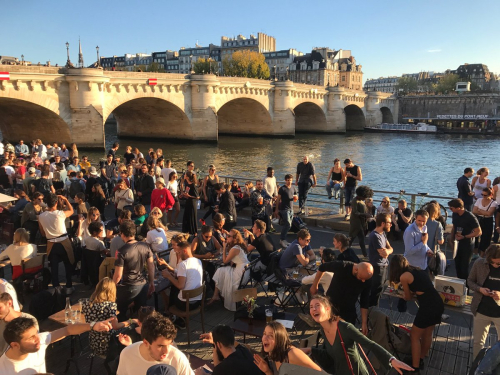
217 98 273 135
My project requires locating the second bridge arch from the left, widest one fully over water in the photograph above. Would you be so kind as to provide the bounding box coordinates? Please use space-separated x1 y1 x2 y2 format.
104 97 193 139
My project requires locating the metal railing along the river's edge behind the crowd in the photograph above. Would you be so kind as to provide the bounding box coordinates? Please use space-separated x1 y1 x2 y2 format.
219 175 456 222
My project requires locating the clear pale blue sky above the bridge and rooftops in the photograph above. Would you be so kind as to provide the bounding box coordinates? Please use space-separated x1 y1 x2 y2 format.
0 0 500 80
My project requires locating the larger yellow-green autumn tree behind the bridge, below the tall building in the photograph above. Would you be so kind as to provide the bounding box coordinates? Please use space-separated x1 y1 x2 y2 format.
222 50 270 79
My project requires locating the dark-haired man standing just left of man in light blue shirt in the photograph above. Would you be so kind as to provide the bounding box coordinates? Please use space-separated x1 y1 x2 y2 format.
368 214 394 307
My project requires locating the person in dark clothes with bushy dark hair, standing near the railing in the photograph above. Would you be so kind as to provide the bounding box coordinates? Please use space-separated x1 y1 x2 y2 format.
349 186 373 258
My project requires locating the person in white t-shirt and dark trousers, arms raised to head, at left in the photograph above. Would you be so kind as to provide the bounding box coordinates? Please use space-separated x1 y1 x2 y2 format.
38 194 75 294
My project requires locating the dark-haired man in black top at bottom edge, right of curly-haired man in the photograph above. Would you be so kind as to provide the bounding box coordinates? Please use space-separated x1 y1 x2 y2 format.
195 325 262 375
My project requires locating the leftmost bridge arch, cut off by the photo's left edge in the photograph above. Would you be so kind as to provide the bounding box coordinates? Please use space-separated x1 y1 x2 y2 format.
0 97 72 143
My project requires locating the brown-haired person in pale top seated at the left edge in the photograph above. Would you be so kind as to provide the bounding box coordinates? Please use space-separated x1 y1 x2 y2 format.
0 228 38 280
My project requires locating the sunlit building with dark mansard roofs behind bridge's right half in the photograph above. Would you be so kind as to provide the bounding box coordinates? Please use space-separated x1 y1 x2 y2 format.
290 47 363 90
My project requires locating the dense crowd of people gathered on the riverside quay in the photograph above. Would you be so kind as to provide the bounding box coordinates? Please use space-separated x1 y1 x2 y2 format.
0 139 500 375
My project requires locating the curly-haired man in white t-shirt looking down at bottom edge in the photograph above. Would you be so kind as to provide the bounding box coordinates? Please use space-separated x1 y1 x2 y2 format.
116 313 194 375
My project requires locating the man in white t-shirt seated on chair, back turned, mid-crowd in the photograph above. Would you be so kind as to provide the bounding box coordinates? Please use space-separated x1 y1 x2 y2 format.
162 242 203 328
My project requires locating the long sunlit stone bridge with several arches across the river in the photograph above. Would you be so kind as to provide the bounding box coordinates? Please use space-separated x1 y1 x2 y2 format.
0 65 398 148
